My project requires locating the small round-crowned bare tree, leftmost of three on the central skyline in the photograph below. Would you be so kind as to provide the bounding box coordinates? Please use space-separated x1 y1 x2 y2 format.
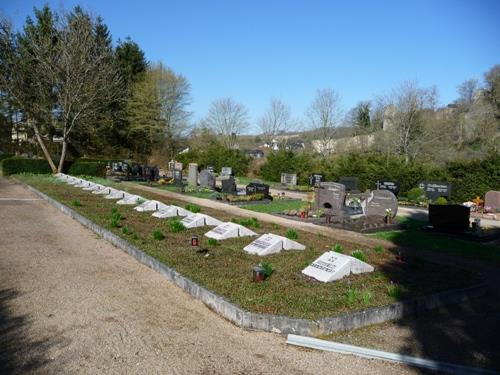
204 98 249 148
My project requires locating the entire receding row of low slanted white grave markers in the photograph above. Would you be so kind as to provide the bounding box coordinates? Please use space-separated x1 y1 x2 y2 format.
56 173 374 282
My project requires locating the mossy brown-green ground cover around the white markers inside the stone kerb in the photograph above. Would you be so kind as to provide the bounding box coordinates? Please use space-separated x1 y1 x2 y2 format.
17 175 480 319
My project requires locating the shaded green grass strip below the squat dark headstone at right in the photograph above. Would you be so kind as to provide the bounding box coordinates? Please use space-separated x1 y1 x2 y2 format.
372 217 500 264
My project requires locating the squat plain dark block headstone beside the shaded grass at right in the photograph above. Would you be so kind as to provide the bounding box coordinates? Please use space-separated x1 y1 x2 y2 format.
429 204 470 233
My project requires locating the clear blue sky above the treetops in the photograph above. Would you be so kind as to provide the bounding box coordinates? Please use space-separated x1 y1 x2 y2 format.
0 0 500 133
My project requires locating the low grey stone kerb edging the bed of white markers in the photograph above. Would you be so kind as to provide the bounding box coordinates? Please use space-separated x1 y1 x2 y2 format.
21 178 486 336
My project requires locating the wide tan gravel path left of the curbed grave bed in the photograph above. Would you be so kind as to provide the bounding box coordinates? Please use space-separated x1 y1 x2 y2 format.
0 178 419 374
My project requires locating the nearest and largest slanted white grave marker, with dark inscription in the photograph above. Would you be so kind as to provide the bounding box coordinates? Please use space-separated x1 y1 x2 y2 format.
302 251 374 283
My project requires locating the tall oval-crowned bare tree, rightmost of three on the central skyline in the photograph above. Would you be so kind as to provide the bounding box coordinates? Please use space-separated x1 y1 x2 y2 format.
307 89 343 156
